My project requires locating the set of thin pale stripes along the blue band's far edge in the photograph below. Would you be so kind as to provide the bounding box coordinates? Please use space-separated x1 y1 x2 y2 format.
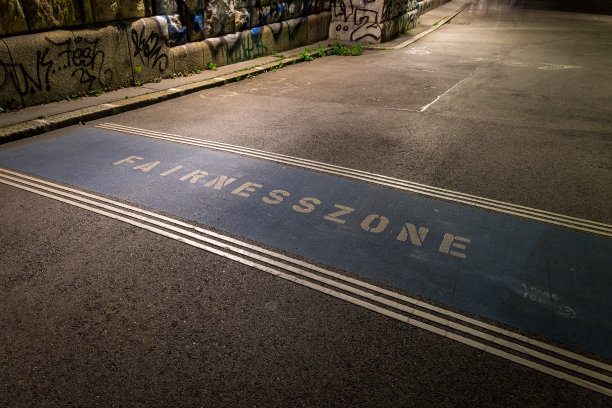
96 123 612 237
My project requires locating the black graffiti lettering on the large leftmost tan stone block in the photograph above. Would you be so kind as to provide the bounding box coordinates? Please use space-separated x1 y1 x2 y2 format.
0 36 113 102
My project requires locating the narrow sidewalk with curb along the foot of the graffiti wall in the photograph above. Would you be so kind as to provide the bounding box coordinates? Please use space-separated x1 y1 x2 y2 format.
0 0 471 143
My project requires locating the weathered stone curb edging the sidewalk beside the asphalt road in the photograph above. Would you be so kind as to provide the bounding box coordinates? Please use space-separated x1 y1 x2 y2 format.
0 47 330 144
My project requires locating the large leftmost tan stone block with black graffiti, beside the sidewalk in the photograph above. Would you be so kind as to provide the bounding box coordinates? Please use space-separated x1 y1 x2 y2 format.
0 25 131 107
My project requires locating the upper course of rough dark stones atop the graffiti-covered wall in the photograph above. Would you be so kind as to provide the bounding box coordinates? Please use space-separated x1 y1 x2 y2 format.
0 0 330 39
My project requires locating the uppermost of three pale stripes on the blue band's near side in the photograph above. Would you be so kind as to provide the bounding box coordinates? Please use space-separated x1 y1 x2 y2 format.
0 167 612 372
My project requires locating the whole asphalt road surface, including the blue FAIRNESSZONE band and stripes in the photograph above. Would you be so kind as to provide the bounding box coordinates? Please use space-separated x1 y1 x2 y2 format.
0 1 612 407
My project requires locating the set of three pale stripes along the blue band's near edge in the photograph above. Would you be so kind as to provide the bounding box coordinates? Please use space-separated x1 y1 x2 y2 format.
0 169 612 396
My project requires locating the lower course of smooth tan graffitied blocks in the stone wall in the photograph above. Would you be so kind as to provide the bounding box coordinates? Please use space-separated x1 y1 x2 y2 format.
0 7 331 108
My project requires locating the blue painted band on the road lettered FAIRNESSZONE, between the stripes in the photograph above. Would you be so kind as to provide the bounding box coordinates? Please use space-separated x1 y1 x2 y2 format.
0 129 612 358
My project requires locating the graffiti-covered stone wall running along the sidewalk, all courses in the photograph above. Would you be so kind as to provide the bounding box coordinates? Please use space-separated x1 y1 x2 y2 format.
0 0 450 109
